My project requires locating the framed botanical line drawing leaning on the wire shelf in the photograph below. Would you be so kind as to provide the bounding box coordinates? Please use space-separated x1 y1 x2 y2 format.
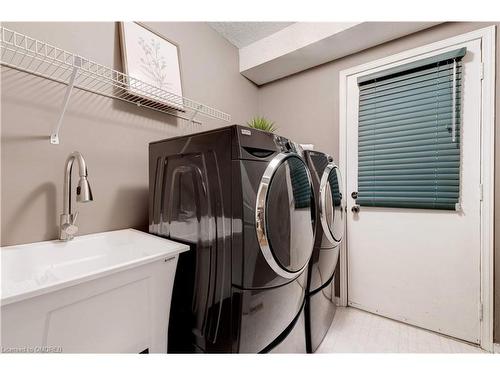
120 22 184 111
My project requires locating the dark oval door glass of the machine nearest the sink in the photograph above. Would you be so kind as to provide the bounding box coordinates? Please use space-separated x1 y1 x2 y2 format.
266 156 314 272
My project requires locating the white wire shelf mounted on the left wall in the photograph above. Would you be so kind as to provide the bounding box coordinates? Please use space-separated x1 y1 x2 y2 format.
0 27 231 122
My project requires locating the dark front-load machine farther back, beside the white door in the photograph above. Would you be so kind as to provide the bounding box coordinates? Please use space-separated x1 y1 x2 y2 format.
304 150 345 353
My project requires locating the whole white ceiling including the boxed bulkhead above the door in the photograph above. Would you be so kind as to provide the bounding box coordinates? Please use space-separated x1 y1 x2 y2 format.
208 22 439 85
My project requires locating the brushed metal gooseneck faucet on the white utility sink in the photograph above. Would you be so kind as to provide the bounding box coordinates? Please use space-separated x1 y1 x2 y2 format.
59 151 94 241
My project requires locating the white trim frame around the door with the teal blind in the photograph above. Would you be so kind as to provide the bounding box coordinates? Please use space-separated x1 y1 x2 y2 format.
339 25 496 352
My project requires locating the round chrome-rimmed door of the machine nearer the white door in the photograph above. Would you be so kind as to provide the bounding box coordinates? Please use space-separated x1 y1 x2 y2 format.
322 164 344 243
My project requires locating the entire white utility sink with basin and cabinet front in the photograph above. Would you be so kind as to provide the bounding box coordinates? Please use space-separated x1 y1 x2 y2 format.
1 229 189 353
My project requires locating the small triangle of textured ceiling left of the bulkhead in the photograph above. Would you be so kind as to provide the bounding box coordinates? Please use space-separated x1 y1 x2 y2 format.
208 22 293 48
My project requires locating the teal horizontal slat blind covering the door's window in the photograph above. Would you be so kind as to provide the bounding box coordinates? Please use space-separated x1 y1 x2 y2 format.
356 48 466 210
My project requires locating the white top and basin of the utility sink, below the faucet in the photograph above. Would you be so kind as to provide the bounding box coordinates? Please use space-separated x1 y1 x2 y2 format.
1 229 189 305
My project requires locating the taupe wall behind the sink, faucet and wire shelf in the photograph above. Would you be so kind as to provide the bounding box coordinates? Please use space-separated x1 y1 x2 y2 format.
1 22 258 245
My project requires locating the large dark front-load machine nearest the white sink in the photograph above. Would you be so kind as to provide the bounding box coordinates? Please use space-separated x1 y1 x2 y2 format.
149 125 314 353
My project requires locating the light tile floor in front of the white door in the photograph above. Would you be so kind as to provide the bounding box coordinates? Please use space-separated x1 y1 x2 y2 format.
317 307 485 353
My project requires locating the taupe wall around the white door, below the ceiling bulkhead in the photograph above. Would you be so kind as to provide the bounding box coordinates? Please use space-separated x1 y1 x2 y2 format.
259 23 500 342
